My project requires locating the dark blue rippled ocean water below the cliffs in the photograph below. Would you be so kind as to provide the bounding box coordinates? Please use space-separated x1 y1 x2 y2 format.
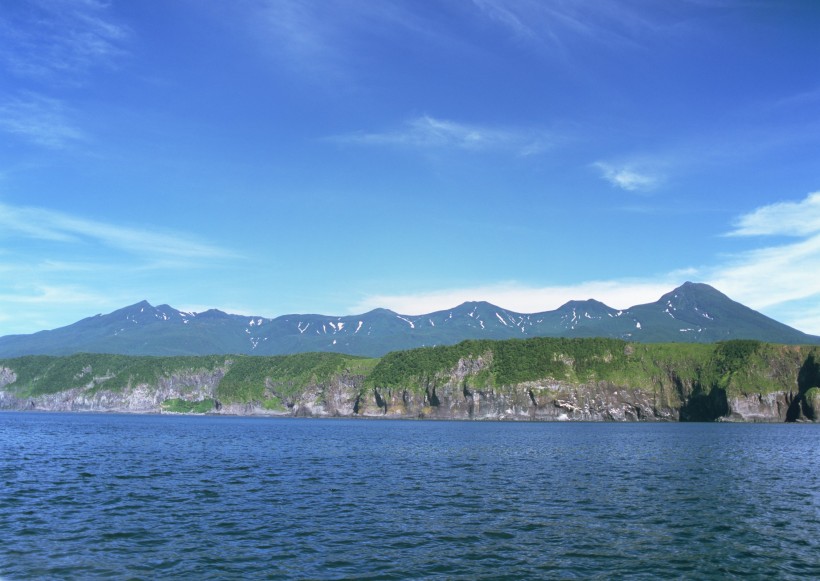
0 413 820 579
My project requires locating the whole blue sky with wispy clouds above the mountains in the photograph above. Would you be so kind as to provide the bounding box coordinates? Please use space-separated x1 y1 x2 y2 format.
0 0 820 335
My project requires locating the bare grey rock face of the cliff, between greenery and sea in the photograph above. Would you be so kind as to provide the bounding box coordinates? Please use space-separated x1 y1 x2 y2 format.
0 357 808 422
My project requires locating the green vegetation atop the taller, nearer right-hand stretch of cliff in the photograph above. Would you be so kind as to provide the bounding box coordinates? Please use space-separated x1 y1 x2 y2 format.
367 338 818 396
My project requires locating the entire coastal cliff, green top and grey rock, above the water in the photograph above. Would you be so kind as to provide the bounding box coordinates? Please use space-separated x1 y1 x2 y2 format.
0 339 820 422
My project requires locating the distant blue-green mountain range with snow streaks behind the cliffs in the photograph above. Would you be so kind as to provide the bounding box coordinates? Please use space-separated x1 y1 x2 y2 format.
0 282 820 357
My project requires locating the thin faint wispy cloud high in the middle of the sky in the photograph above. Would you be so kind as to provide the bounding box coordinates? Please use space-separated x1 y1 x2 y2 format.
329 115 551 155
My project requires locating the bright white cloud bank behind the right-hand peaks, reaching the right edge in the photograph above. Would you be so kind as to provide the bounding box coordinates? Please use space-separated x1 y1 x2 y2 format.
350 193 820 335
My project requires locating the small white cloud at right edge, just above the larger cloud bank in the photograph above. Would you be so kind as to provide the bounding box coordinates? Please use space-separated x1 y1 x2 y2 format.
728 192 820 236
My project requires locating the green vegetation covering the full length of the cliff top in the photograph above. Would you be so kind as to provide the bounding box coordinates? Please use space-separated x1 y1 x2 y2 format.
0 338 820 408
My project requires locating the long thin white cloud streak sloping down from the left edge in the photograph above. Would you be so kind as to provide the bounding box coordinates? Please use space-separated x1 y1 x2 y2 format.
0 203 234 260
